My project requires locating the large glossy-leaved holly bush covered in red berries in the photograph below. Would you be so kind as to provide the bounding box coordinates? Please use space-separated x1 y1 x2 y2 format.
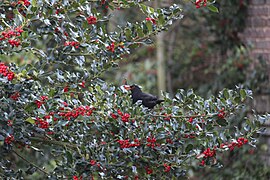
0 0 268 179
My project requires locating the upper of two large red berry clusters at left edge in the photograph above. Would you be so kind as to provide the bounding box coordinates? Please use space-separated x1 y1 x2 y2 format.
0 27 23 47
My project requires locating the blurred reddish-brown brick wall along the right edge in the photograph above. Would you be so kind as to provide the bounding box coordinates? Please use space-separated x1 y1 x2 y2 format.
241 0 270 165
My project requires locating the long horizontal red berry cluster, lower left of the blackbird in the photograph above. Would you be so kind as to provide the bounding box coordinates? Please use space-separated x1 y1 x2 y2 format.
58 106 93 120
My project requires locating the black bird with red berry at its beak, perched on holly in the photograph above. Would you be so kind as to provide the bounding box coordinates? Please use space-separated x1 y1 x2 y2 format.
124 85 164 109
